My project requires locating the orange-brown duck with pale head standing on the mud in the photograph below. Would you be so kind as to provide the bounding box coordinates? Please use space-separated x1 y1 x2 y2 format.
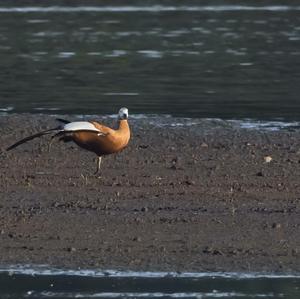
6 108 130 174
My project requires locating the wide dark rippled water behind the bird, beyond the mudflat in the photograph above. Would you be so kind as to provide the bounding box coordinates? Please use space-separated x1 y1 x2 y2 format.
0 0 300 120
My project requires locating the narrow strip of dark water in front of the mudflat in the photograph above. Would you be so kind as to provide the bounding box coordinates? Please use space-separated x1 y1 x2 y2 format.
0 266 300 299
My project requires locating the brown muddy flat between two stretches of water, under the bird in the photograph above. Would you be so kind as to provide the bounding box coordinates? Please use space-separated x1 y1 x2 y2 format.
0 115 300 272
